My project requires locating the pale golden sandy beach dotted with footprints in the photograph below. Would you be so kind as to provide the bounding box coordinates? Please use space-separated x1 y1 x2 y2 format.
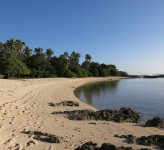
0 78 164 150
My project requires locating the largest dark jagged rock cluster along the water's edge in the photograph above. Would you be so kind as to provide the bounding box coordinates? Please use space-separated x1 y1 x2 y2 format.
53 107 140 123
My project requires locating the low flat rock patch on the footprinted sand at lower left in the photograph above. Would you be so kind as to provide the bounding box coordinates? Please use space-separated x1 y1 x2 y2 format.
21 130 63 143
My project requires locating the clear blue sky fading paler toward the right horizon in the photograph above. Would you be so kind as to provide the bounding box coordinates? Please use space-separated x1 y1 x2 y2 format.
0 0 164 74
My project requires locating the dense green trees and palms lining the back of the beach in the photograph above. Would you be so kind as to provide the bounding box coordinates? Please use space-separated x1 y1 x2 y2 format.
0 39 128 78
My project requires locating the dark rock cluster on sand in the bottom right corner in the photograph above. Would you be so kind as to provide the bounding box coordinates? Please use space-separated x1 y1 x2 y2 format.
115 135 164 148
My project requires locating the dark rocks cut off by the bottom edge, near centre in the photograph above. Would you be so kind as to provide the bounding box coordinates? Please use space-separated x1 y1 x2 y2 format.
75 141 149 150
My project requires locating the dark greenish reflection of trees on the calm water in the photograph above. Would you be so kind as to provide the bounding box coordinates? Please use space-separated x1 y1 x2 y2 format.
75 81 119 105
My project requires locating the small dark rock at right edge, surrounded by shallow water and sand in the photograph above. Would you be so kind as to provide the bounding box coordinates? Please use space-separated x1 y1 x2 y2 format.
145 117 164 128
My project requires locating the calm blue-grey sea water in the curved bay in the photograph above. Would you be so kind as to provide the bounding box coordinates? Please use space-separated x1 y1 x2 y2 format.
75 78 164 120
